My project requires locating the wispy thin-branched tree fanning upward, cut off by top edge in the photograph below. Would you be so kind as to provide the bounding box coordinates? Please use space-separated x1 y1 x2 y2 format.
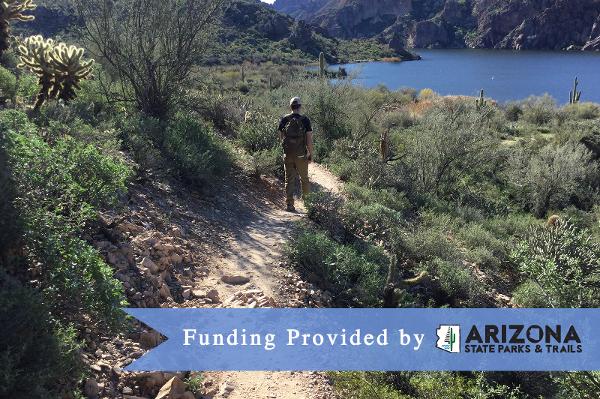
72 0 227 120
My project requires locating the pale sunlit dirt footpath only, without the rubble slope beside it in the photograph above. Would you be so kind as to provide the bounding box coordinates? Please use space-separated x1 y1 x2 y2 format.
200 164 341 399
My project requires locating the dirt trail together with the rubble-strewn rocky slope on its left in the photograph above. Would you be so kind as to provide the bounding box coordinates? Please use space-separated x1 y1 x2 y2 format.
83 165 340 399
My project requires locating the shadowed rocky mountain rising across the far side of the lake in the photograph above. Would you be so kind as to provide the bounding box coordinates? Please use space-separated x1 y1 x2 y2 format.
273 0 600 50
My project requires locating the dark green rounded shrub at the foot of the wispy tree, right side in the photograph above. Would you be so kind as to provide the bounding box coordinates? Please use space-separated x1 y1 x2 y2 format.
161 113 231 186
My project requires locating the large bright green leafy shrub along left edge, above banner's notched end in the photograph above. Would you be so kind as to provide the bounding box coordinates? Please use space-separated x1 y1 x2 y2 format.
3 131 130 322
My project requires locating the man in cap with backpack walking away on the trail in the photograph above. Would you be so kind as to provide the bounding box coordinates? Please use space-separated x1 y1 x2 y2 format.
279 97 313 212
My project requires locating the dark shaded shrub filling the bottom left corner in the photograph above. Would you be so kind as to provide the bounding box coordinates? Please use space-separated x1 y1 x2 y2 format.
0 277 83 399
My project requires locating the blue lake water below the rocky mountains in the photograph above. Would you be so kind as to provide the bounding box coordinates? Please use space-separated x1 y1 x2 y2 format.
334 50 600 104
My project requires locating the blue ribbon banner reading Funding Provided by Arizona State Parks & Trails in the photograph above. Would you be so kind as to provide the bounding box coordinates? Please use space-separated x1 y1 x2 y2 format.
125 309 600 371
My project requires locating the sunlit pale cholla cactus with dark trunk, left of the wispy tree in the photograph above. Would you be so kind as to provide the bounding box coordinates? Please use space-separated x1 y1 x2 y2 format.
19 36 94 109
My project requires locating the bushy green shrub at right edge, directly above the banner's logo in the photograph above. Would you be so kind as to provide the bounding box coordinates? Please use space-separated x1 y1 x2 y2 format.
511 221 600 308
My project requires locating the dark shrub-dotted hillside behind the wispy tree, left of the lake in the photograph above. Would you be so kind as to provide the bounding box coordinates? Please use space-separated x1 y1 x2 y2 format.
15 0 412 65
